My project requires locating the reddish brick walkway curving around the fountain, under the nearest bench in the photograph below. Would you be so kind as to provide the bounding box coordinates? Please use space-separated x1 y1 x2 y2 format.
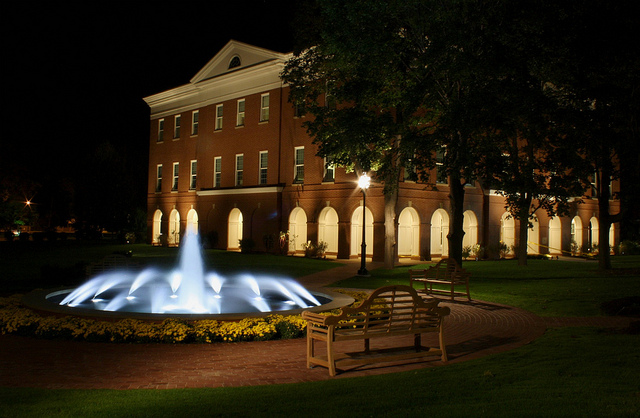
0 263 629 389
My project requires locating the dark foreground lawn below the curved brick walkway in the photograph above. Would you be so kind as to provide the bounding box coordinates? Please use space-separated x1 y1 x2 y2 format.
0 328 640 417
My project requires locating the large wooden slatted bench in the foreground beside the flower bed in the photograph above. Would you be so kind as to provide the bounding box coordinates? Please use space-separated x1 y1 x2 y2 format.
302 285 450 376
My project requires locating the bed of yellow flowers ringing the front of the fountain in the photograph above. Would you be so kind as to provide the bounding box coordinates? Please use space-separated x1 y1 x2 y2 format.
0 291 366 343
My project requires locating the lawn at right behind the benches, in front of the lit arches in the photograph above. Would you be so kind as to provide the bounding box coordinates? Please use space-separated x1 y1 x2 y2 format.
333 256 640 316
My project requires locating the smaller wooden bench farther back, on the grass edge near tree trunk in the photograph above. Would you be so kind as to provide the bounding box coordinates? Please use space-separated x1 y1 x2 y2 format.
409 258 471 300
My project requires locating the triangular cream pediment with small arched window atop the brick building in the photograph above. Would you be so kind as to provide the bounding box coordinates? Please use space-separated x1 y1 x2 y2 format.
190 40 288 84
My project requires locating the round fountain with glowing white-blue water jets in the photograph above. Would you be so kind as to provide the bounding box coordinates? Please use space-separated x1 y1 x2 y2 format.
25 233 349 319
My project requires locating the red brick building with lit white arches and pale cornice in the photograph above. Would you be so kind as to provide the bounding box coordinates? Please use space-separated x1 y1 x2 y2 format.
144 41 617 260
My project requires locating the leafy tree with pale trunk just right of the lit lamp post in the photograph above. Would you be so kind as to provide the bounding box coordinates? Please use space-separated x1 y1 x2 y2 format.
282 0 440 268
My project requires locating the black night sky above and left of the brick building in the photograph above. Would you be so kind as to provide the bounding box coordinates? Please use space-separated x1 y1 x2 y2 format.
0 0 293 199
